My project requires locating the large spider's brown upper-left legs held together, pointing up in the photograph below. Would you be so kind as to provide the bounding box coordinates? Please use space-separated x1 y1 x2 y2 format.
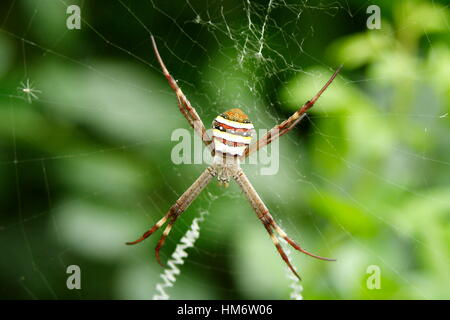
151 36 213 150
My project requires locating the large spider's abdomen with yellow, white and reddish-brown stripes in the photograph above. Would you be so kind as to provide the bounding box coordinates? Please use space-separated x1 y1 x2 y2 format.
213 108 254 156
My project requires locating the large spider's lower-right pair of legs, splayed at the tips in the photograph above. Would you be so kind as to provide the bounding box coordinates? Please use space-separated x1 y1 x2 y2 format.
234 170 335 279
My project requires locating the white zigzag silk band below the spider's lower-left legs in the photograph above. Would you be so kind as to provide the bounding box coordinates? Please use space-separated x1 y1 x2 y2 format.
153 211 208 300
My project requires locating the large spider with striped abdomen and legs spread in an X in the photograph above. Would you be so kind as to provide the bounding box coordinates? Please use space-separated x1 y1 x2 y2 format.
126 36 342 279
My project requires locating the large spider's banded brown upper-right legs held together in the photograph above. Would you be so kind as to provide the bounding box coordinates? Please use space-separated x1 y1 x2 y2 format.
243 65 342 158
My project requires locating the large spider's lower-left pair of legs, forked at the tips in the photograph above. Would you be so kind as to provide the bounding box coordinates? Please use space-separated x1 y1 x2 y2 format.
126 167 216 265
